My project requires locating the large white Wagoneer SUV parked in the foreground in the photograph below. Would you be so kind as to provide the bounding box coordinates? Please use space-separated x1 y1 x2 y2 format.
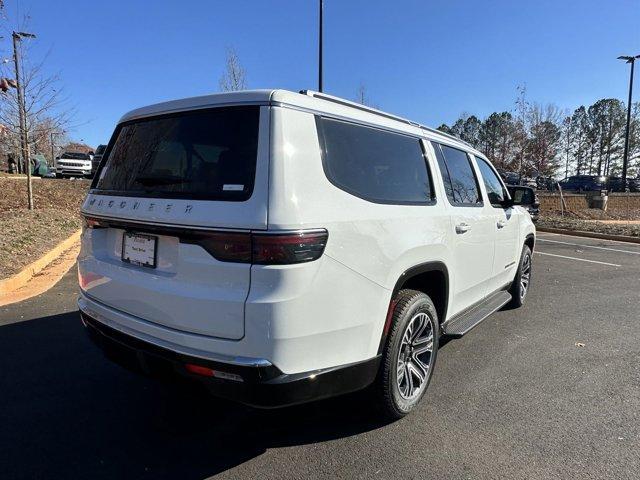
78 90 535 418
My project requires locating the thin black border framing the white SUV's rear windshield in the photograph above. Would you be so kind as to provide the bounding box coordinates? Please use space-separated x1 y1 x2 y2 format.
88 102 264 203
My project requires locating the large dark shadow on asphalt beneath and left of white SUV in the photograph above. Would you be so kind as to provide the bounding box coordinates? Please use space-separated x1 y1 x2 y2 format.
0 312 390 480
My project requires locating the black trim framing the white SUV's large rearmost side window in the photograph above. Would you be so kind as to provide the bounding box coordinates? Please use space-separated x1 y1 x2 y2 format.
314 114 438 206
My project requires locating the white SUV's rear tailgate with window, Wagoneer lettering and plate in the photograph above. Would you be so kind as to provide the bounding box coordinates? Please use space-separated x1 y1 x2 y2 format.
79 106 269 339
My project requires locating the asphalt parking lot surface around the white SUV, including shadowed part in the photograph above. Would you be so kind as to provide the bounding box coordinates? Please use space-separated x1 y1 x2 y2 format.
0 233 640 480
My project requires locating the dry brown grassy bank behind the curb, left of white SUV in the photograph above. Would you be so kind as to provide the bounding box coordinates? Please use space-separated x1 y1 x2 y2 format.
0 175 90 278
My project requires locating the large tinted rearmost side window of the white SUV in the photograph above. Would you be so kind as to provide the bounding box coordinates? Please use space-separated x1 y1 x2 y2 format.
316 117 434 204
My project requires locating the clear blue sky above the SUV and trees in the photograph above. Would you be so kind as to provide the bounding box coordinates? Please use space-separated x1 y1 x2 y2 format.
1 0 640 146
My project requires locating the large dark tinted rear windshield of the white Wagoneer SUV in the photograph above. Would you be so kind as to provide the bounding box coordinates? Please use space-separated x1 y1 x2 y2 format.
95 106 260 201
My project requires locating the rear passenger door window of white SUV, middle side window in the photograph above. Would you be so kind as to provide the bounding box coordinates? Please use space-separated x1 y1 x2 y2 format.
433 143 482 207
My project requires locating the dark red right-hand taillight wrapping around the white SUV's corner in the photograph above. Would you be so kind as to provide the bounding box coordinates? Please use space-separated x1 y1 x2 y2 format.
192 230 329 265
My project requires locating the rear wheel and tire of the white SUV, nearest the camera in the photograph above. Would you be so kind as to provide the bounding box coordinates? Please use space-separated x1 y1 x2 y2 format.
376 290 440 420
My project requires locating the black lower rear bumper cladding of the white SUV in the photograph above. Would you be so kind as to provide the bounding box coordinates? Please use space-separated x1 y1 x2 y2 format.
80 312 380 408
